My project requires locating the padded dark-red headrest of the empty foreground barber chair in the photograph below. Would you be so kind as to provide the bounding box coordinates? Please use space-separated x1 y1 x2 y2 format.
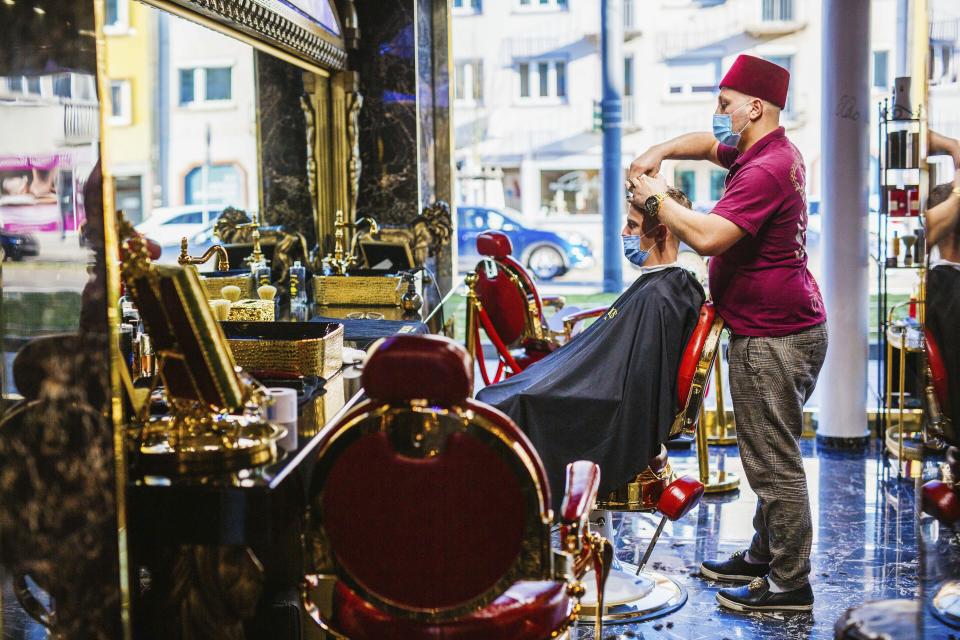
362 336 473 405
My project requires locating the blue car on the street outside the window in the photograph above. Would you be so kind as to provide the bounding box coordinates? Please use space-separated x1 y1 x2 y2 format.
457 206 593 280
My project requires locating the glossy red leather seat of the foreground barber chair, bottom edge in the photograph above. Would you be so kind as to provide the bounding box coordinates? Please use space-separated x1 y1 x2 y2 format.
334 582 572 640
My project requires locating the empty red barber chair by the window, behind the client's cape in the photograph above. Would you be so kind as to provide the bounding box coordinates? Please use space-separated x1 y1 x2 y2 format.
467 231 607 385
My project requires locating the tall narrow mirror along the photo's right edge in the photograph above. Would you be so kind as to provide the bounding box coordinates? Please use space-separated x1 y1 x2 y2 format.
922 0 960 637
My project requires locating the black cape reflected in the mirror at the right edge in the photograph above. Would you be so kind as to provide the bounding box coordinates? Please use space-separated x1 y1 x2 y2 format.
926 264 960 428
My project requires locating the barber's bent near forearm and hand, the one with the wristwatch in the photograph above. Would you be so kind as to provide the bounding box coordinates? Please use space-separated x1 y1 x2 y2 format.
628 175 746 256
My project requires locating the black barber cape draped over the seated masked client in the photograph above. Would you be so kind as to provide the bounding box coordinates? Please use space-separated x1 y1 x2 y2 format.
477 266 704 510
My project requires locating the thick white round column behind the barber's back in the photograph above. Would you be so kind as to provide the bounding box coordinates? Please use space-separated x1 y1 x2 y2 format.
817 0 872 444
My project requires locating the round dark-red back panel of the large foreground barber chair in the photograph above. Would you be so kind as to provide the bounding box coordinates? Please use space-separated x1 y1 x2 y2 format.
321 430 532 608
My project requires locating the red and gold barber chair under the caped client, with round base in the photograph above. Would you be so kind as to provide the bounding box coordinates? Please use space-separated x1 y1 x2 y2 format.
582 302 720 624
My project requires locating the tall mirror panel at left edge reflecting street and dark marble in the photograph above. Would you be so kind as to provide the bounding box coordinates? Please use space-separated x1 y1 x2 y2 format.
0 0 122 638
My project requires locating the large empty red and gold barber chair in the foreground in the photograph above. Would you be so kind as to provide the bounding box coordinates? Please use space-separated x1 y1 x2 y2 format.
303 336 613 640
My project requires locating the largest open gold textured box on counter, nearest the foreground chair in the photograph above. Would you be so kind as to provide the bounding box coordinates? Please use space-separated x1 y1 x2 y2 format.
220 322 343 378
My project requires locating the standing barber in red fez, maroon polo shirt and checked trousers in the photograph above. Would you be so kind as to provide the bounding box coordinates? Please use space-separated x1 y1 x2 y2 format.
627 55 827 611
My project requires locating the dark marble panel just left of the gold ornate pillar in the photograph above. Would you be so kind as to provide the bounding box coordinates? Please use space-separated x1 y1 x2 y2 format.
255 51 317 247
